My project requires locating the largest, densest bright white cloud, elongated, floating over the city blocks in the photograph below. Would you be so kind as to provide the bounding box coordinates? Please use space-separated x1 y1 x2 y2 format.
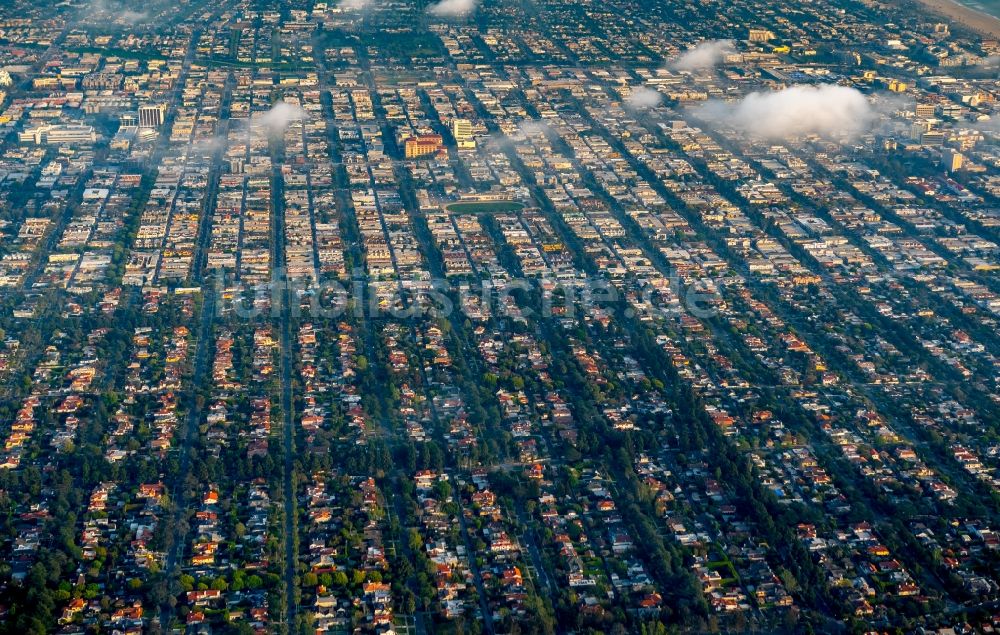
694 84 881 139
